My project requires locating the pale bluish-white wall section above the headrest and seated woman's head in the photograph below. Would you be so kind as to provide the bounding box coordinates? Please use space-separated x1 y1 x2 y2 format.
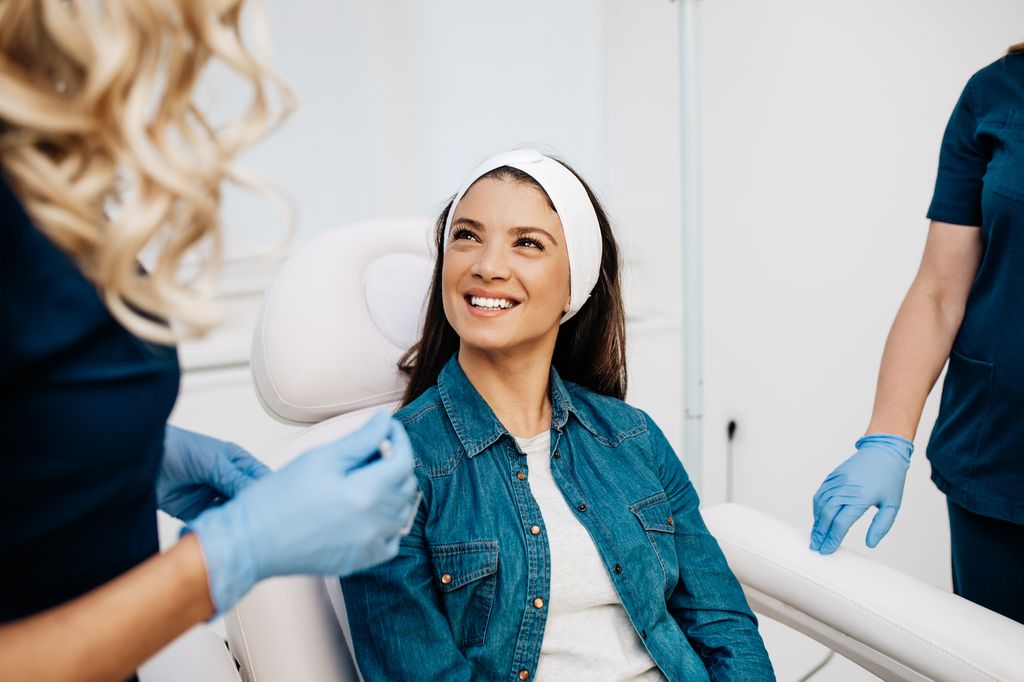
214 0 607 253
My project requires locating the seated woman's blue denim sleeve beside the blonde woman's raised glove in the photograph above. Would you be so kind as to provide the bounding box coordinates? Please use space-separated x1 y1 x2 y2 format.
341 499 473 682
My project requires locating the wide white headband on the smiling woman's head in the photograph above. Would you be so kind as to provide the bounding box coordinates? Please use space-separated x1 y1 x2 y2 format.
444 150 601 324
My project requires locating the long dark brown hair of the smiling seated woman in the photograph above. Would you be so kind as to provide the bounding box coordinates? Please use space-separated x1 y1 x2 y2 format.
398 161 626 407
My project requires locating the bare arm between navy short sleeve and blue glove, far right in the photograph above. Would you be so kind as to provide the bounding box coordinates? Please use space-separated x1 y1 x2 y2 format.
867 220 984 440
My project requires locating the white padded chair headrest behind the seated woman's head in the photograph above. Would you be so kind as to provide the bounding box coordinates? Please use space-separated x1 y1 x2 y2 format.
252 219 433 424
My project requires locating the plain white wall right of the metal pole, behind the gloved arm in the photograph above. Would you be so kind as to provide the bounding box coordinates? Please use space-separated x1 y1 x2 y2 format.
699 0 1024 586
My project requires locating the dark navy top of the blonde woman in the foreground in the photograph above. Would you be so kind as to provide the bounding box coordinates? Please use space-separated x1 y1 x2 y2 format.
0 177 179 622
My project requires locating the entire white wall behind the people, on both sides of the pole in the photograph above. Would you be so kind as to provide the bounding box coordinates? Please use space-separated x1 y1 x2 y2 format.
178 0 1024 679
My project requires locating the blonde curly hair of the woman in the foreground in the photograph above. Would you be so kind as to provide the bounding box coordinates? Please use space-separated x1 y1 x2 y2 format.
0 0 293 343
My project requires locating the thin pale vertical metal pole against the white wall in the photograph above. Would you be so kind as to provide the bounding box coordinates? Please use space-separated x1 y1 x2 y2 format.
678 0 703 491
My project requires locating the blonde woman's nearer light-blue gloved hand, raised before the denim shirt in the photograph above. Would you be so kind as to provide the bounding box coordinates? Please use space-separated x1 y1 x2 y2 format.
191 413 417 611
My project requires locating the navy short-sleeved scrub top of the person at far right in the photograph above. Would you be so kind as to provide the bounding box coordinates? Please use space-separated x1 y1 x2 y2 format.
928 54 1024 523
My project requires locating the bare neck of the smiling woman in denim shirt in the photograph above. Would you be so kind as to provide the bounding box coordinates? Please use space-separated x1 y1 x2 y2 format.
459 346 554 438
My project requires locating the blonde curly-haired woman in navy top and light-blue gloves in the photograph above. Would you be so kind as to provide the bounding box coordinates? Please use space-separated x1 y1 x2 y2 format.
0 0 416 680
